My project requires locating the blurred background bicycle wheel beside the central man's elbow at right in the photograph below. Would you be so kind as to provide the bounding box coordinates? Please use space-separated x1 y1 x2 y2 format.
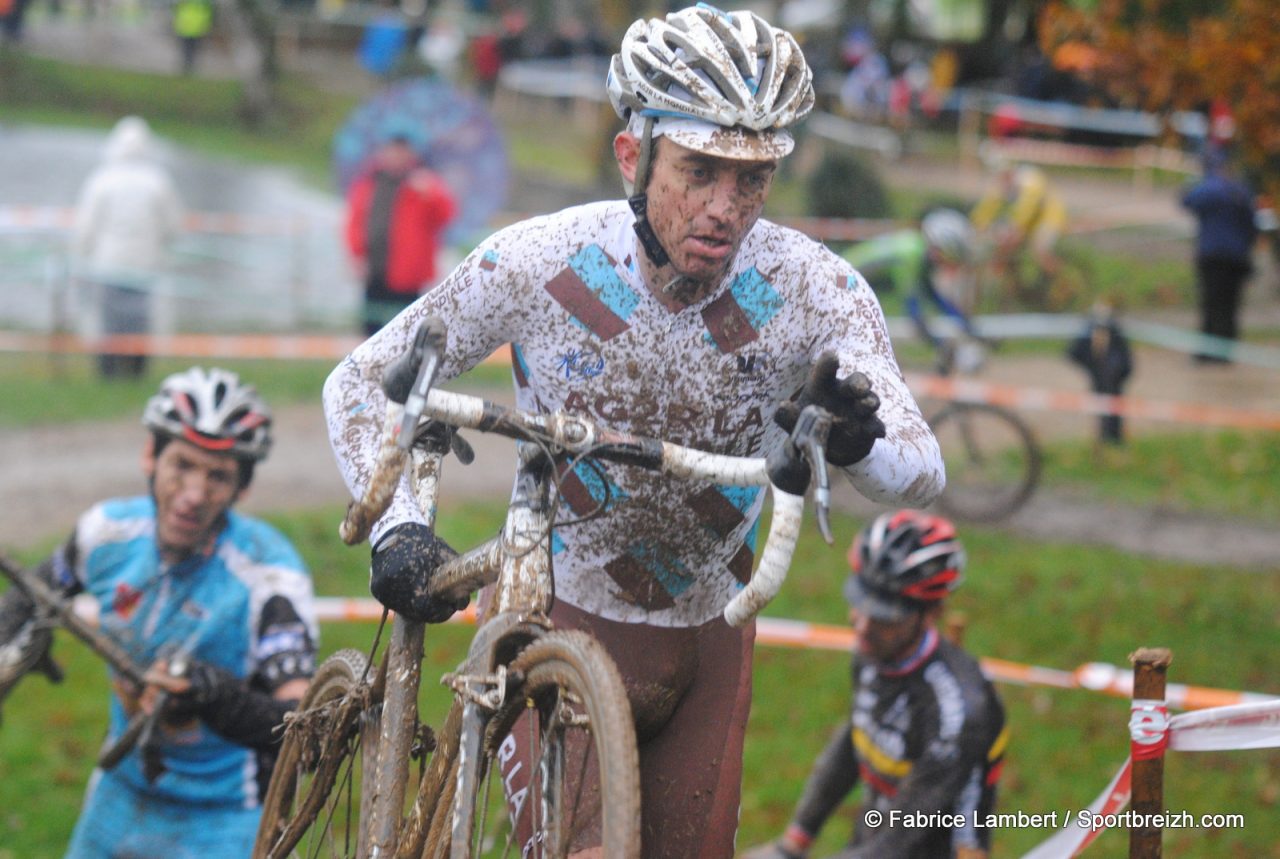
929 402 1041 522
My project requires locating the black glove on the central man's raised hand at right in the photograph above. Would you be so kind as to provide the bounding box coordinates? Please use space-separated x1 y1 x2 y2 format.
773 352 884 466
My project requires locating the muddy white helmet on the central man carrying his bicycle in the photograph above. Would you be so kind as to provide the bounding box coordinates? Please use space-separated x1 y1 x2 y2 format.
605 3 814 160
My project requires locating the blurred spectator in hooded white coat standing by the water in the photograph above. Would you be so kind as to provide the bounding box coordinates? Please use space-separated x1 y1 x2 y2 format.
72 116 183 378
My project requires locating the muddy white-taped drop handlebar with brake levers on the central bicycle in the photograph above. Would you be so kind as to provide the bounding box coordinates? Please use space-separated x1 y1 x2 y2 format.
339 320 829 626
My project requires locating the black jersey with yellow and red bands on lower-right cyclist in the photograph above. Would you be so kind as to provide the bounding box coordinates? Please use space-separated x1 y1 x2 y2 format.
794 630 1007 859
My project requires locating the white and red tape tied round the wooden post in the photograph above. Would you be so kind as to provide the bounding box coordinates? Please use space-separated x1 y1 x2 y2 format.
1023 699 1280 859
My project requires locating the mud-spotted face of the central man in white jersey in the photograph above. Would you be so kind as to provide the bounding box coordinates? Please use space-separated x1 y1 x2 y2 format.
648 138 778 284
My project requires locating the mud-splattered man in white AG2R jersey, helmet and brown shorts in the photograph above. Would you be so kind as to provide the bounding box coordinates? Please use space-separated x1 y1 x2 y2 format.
324 4 943 856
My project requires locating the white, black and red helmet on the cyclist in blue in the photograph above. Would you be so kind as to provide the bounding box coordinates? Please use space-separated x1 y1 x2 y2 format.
142 367 271 461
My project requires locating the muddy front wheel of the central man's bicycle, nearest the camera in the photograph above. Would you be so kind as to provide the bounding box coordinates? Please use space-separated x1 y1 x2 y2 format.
429 631 640 859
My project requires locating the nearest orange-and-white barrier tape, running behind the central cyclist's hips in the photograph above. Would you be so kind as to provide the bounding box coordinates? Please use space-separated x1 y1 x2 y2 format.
307 597 1277 709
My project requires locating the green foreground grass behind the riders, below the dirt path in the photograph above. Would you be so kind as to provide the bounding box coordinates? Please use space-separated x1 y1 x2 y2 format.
0 504 1280 859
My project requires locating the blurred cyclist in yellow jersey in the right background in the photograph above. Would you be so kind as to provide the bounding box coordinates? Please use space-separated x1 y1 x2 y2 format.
969 156 1068 295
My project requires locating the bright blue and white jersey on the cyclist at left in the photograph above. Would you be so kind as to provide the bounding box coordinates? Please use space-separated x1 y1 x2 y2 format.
52 497 319 808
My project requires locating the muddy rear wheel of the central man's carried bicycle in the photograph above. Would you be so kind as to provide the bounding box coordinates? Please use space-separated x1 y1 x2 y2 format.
253 649 379 859
